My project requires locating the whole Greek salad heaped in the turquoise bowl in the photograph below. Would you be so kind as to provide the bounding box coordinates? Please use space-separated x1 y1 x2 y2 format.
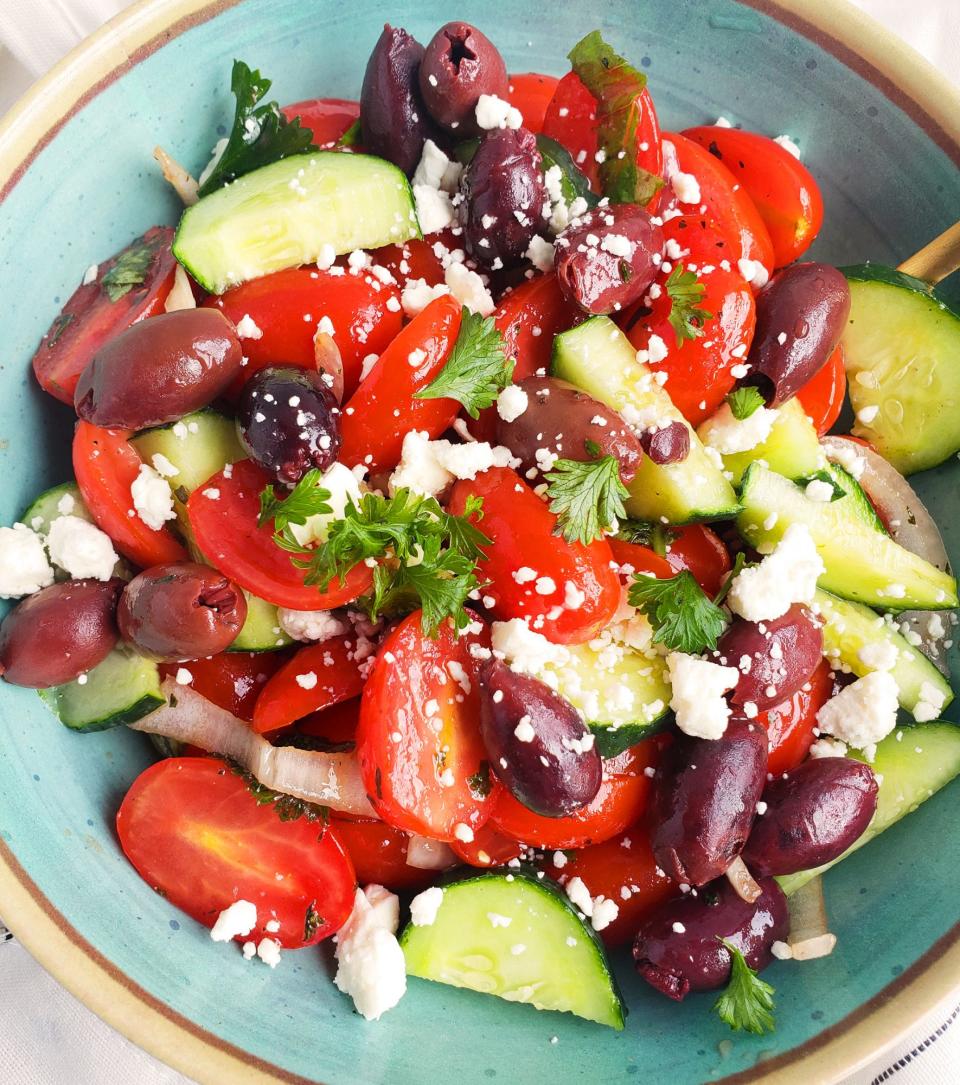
0 22 960 1033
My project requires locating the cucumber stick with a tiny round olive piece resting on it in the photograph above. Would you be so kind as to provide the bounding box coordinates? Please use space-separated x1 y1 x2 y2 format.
551 317 738 524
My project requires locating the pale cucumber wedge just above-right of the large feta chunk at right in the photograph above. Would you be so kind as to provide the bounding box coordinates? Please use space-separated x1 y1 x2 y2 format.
737 463 957 611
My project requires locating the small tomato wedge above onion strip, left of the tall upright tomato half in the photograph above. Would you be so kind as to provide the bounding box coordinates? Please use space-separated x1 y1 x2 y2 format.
253 637 363 735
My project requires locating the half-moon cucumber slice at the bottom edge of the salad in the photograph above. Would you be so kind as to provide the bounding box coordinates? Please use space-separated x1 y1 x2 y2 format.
400 872 627 1030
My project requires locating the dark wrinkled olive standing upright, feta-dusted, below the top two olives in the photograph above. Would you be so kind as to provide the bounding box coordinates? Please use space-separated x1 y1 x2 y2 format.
457 128 547 267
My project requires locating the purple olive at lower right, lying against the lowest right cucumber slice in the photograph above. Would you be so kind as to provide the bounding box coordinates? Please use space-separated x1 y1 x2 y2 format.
743 757 876 875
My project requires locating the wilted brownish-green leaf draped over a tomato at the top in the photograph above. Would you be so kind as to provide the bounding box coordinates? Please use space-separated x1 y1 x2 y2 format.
567 30 664 204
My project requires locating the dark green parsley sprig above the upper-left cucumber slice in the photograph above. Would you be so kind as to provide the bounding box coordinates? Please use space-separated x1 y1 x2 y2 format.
199 61 318 196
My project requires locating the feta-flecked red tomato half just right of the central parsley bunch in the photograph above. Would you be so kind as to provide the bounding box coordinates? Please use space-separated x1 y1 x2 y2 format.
449 468 620 644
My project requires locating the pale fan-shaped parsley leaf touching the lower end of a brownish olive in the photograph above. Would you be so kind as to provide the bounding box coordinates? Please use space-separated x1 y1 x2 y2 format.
545 453 628 544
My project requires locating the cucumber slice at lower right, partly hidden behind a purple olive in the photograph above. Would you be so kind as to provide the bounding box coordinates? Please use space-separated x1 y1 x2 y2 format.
777 722 960 895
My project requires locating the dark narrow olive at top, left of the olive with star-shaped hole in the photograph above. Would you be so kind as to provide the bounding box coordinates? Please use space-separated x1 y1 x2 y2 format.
360 23 436 177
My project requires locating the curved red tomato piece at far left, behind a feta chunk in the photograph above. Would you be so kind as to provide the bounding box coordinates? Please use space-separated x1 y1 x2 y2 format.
73 422 187 569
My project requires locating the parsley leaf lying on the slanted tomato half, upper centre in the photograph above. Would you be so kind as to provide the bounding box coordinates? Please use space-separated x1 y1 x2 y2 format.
417 308 513 418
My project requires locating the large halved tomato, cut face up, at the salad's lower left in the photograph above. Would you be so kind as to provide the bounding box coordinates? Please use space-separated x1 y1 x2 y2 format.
117 757 357 949
